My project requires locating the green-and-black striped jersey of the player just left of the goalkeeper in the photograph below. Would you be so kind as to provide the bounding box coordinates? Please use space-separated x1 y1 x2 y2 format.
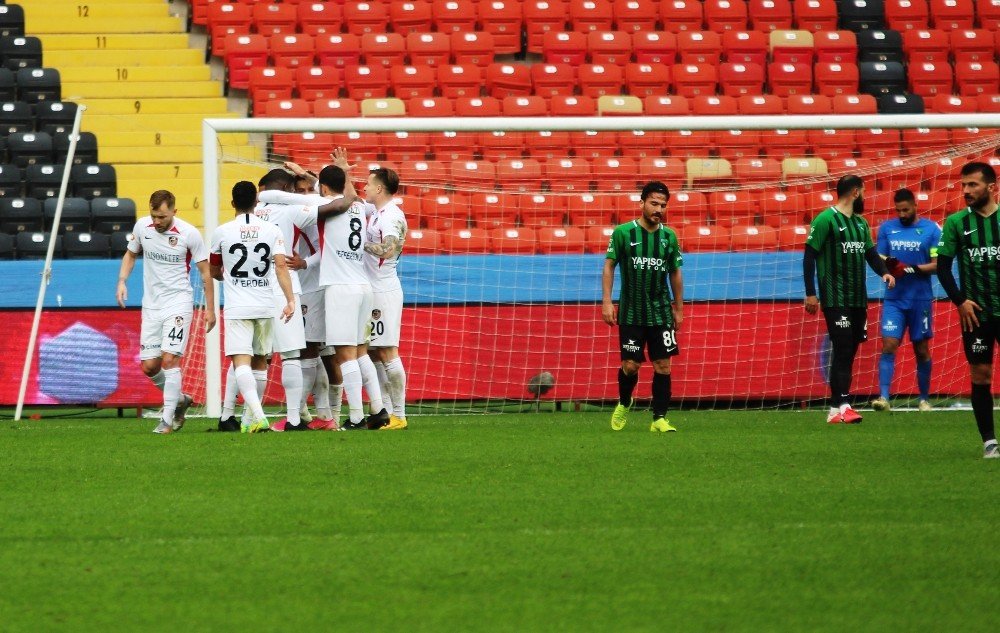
806 207 875 308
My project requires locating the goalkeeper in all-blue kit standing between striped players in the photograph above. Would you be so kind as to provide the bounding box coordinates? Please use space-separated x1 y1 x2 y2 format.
872 189 941 411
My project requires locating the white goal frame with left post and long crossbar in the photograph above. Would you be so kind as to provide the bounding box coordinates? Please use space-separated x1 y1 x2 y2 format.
202 113 1000 417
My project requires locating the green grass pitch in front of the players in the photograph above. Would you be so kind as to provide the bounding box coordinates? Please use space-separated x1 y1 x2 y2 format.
0 411 1000 632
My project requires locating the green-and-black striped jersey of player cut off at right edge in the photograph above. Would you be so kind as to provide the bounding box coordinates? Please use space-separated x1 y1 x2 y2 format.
938 207 1000 320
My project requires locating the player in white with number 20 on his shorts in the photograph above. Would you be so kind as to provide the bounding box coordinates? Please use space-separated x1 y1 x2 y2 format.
364 167 407 431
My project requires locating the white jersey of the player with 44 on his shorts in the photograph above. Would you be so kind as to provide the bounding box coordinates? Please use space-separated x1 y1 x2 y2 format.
127 217 208 311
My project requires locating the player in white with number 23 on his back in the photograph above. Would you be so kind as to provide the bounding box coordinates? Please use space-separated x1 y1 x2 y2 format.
211 180 297 433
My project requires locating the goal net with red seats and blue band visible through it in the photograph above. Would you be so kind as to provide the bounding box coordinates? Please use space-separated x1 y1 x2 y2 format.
186 115 1000 414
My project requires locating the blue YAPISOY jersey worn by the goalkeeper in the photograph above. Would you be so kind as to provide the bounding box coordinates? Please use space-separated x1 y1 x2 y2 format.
876 218 941 307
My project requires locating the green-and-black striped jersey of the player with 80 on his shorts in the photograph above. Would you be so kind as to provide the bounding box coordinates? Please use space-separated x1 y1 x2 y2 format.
607 220 684 327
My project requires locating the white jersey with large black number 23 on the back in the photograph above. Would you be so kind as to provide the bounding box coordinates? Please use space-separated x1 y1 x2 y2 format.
212 213 285 319
